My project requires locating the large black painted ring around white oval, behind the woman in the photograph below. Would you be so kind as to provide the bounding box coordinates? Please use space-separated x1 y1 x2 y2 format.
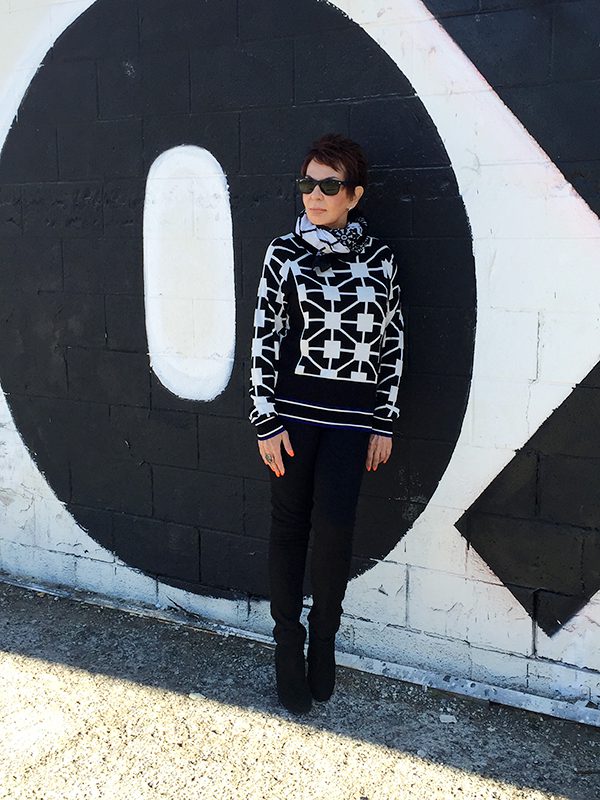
0 0 475 596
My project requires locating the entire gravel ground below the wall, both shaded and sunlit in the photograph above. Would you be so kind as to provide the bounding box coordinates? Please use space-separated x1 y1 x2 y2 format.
0 583 600 800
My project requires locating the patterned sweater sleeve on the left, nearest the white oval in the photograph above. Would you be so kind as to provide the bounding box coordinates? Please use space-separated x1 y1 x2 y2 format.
249 241 289 439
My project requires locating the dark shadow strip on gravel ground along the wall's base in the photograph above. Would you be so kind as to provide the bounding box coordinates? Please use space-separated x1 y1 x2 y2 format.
0 583 600 800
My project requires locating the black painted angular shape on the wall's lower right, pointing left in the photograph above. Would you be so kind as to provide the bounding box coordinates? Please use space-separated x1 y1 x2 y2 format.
456 366 600 635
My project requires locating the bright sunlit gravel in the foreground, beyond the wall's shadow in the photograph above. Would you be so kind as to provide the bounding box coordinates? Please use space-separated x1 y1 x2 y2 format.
0 653 559 800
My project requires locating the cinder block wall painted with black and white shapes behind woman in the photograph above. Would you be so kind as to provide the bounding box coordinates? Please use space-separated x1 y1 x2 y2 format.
0 0 600 712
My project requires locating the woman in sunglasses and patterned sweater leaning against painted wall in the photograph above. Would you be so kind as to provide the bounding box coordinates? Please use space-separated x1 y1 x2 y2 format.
250 134 403 713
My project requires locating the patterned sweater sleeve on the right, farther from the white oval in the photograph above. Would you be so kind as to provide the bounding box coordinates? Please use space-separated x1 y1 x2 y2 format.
373 251 404 436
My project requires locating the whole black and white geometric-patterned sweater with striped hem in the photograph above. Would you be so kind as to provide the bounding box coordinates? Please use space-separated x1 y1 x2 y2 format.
249 233 404 439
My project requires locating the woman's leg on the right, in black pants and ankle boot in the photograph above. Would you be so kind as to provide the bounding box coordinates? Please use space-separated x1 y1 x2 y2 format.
308 428 370 700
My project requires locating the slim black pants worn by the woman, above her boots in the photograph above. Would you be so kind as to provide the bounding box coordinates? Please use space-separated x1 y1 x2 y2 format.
269 419 370 644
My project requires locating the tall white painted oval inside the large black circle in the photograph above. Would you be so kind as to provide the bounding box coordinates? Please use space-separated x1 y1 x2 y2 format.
144 145 235 400
